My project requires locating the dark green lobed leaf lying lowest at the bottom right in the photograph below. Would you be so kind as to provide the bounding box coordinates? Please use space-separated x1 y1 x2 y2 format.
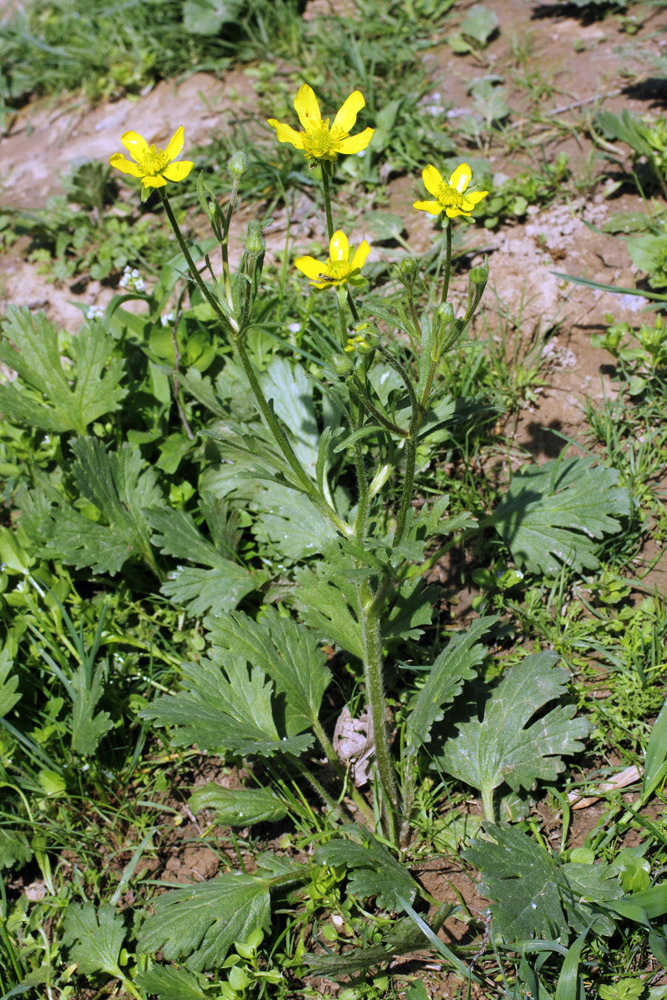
463 826 623 944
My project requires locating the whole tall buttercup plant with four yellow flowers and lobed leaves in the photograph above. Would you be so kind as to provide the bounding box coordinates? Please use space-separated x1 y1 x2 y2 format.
103 86 586 974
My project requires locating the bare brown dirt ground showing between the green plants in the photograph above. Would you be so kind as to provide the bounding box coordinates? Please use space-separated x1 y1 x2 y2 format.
0 0 667 997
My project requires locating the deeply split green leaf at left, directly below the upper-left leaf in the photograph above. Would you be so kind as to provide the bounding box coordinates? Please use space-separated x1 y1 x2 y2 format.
22 438 163 576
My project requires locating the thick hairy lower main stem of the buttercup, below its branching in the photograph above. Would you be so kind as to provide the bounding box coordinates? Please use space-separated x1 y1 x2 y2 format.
357 583 399 846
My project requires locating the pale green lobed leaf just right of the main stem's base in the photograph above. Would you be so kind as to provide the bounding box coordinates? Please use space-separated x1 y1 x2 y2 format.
438 652 589 818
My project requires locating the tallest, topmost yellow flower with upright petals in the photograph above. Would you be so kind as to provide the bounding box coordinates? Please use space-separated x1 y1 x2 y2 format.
268 83 375 160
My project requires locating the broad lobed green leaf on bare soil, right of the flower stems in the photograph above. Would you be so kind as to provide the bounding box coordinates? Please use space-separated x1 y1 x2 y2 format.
483 458 631 576
